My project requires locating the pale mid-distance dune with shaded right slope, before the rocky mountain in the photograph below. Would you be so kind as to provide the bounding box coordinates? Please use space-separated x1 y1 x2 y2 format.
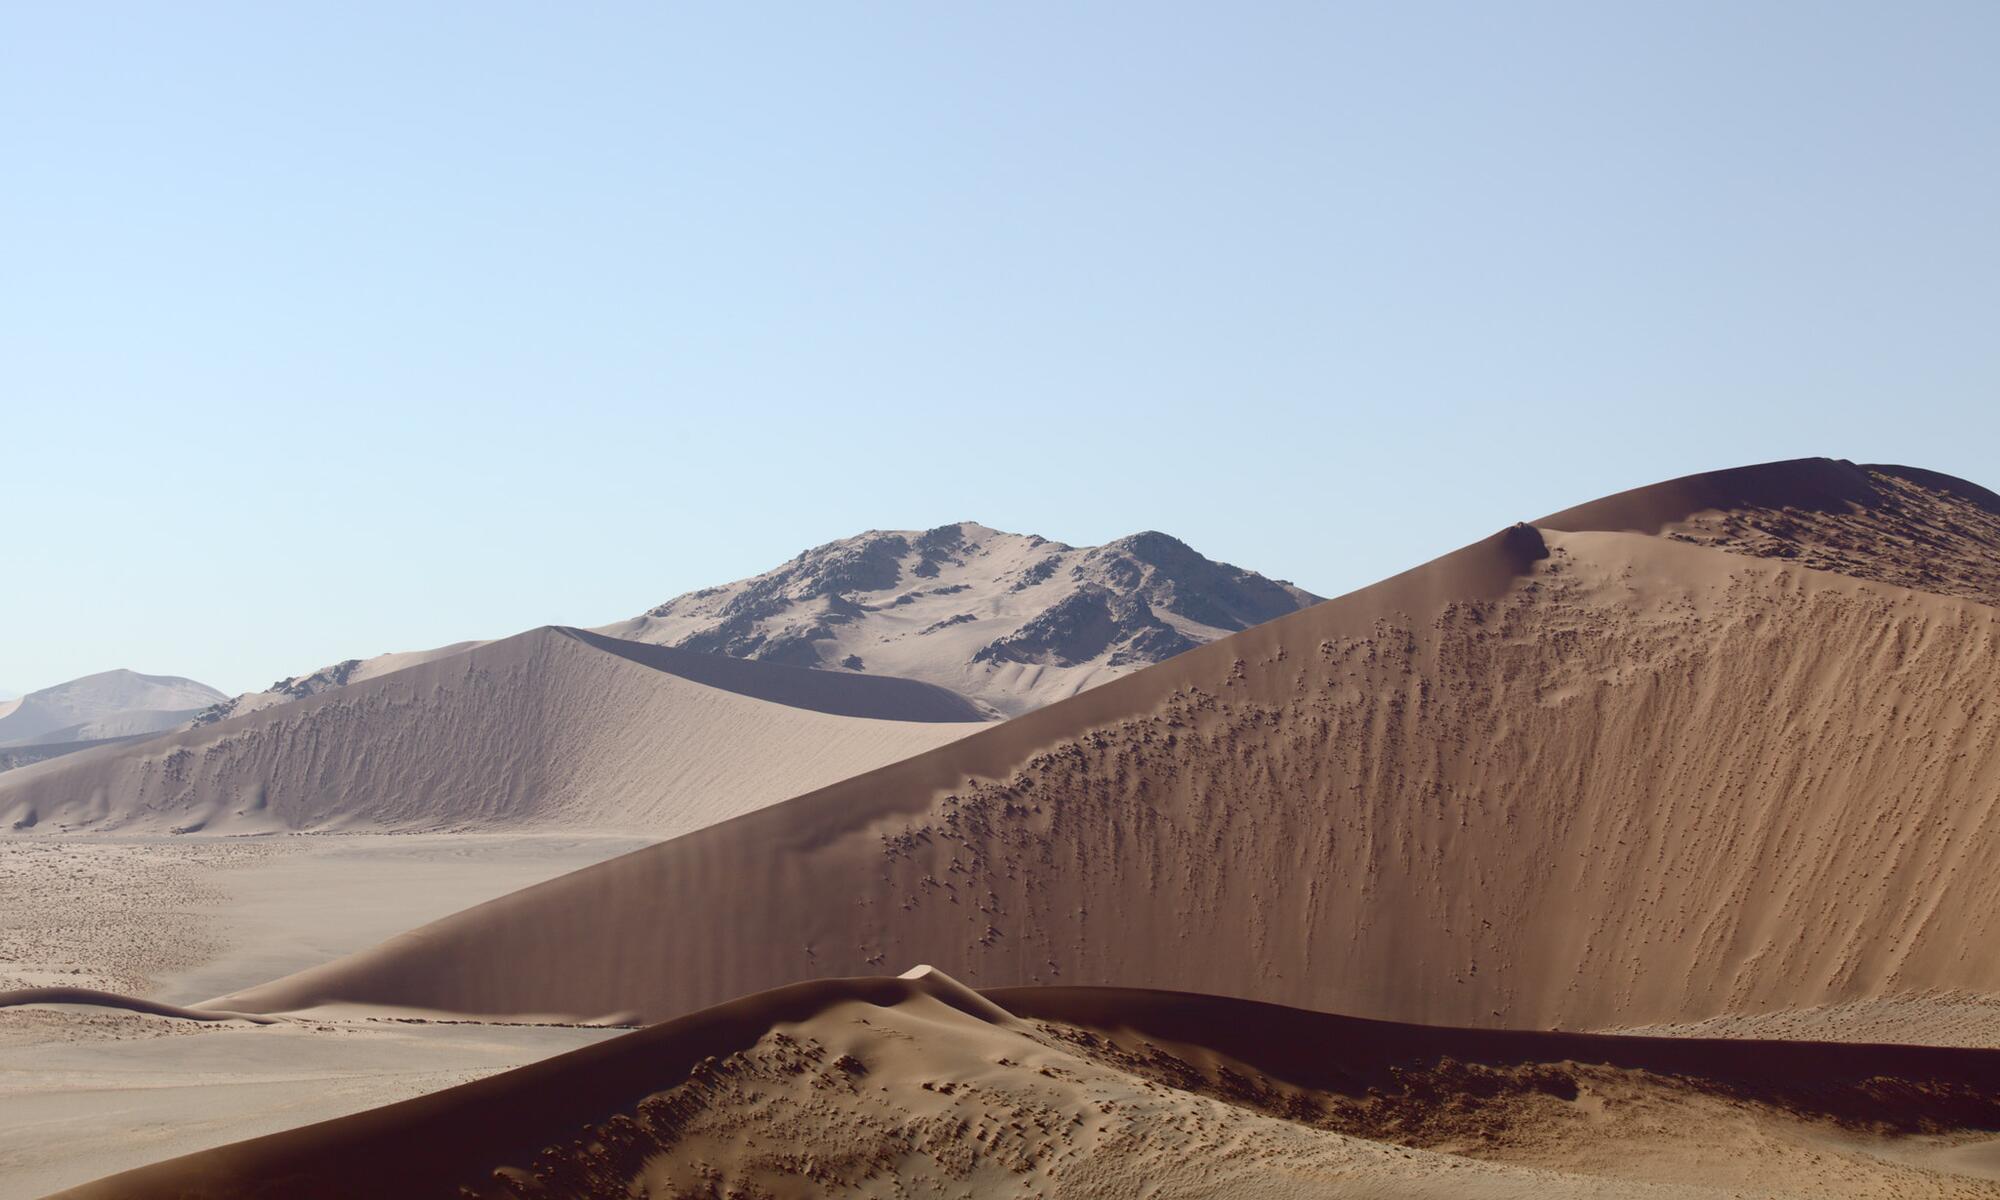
0 628 980 836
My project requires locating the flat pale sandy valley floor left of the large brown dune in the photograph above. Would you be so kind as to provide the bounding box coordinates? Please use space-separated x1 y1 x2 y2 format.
0 834 638 1200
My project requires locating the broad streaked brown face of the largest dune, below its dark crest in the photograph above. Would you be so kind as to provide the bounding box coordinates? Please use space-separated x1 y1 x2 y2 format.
222 464 2000 1040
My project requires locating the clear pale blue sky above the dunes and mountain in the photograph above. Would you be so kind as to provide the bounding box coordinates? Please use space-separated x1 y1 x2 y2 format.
0 0 2000 692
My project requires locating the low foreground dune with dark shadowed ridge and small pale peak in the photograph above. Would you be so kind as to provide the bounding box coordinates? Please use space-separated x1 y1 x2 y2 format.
62 968 2000 1200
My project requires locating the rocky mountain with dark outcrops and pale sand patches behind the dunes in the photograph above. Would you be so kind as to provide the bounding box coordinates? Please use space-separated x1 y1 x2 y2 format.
600 522 1320 716
